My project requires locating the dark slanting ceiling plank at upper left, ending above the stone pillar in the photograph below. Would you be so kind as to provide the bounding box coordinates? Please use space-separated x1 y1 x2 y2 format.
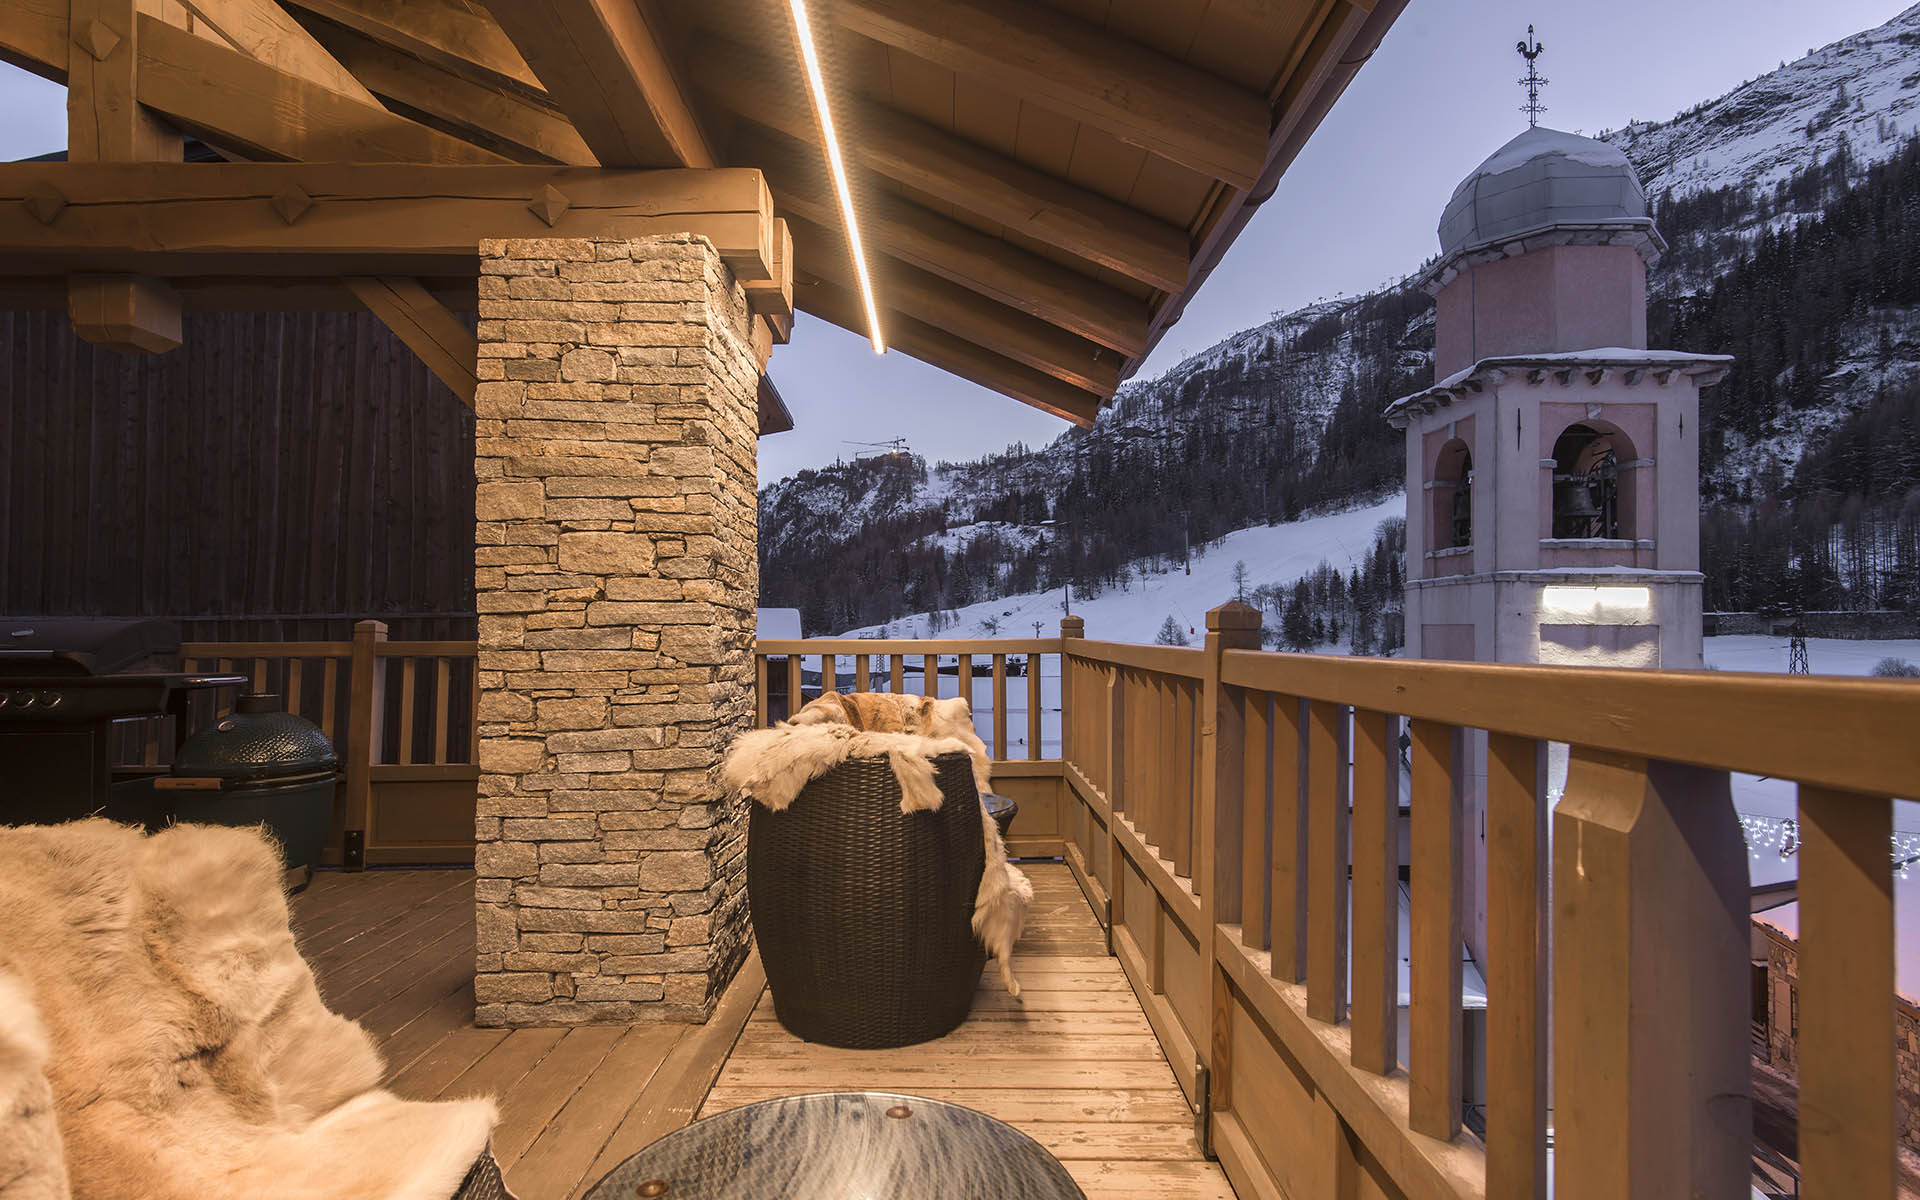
315 21 599 167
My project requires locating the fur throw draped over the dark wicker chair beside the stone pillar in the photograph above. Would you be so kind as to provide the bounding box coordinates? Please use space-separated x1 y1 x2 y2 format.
722 691 1033 996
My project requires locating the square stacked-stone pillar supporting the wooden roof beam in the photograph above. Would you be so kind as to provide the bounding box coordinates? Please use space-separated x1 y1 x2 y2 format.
474 236 758 1025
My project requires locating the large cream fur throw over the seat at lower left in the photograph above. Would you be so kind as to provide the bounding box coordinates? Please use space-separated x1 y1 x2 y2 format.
0 820 493 1200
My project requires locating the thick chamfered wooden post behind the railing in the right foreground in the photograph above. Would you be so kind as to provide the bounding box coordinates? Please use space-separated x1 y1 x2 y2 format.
1551 747 1753 1200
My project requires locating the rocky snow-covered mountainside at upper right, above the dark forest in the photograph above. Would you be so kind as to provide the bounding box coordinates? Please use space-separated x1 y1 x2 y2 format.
1601 4 1920 196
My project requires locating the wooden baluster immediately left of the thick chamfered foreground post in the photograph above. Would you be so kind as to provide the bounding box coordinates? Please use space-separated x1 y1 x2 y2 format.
1484 733 1549 1200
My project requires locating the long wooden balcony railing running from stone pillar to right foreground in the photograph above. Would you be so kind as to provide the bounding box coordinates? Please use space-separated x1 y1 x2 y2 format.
758 605 1920 1200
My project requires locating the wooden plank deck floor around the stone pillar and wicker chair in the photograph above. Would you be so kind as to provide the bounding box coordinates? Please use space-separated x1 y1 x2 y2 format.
294 864 1233 1200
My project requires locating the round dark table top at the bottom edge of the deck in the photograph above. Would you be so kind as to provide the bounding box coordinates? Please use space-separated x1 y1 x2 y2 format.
586 1092 1085 1200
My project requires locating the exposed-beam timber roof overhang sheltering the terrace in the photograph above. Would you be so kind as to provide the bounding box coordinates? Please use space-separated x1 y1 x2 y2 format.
0 0 1405 424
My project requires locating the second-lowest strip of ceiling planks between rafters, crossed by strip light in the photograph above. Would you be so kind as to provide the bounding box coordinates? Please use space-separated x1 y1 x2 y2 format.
739 136 1146 355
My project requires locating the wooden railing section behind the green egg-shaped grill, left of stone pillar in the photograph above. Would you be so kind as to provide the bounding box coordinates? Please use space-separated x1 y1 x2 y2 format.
115 620 480 866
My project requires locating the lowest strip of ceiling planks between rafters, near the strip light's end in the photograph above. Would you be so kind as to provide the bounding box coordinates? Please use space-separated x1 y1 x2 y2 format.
795 221 1121 396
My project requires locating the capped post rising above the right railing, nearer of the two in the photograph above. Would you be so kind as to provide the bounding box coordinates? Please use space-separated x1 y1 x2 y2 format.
1194 601 1260 1159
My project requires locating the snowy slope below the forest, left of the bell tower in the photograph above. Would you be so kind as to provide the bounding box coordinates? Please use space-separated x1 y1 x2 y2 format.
845 495 1407 645
